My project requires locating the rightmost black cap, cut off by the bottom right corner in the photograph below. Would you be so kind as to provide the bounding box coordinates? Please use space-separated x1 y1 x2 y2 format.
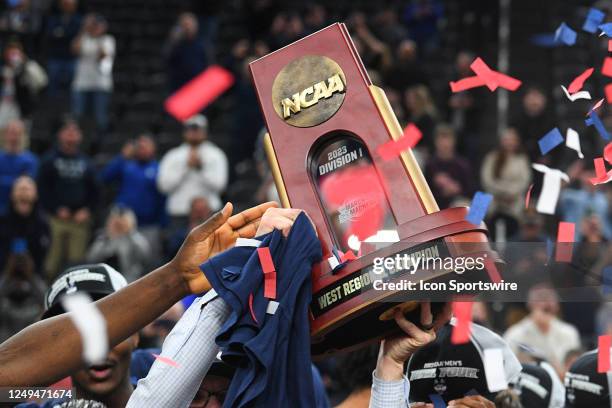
565 349 612 408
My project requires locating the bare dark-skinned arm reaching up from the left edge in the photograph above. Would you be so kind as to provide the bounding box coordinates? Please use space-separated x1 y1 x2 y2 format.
0 203 276 386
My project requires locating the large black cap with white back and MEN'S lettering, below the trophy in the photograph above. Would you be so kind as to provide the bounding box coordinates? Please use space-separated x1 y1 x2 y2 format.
407 319 521 402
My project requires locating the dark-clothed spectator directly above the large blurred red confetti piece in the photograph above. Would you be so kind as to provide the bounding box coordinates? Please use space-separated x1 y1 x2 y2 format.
164 13 211 92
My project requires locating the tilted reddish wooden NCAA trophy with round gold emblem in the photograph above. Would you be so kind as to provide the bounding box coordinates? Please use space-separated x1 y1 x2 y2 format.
250 23 501 355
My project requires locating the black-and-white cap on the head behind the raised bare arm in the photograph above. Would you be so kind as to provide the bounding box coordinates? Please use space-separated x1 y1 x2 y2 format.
42 263 127 319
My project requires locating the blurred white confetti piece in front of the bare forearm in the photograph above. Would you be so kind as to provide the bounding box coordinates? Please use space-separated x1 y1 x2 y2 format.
61 292 108 364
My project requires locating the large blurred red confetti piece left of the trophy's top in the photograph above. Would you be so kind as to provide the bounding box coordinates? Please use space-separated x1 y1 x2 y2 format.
165 65 234 121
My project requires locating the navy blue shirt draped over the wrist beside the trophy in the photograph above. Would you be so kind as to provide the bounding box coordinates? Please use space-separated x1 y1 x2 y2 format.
202 214 322 408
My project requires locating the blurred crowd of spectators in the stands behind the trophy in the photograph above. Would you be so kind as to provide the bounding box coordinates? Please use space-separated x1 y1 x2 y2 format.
0 0 612 404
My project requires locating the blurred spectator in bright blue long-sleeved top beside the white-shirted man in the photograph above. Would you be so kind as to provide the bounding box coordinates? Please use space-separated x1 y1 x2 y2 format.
101 134 167 258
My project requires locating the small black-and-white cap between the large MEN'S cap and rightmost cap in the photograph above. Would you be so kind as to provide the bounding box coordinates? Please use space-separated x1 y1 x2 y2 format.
512 361 565 408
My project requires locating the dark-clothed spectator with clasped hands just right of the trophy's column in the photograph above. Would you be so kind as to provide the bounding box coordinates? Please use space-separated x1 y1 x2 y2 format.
425 125 474 208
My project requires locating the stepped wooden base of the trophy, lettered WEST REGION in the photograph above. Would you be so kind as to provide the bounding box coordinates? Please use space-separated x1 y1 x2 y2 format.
311 207 503 356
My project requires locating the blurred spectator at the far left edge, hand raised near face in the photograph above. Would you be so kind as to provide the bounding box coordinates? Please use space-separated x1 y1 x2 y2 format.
0 39 47 128
